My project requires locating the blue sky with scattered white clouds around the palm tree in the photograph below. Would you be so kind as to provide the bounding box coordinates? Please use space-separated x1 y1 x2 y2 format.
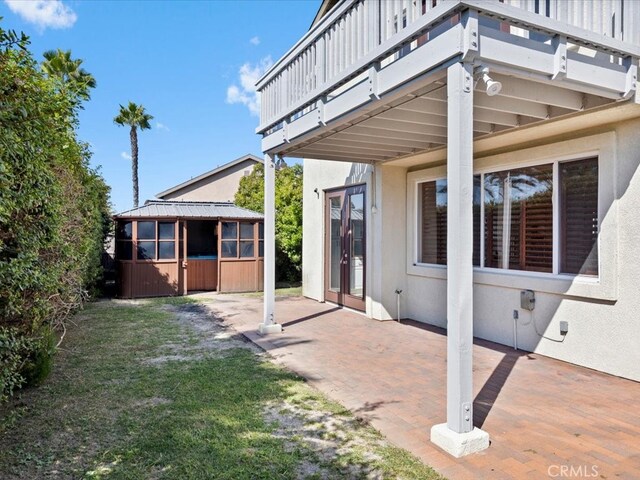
0 0 320 211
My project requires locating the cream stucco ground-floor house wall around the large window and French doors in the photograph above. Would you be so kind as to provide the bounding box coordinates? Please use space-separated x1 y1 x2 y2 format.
303 119 640 381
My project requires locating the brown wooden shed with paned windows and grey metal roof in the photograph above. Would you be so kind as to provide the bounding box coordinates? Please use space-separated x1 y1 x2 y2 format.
114 200 264 298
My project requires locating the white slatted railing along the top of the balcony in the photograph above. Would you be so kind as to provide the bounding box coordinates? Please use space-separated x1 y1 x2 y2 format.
257 0 640 133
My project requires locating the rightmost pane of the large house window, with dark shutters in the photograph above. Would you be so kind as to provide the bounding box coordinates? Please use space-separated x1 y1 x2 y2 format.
559 158 598 275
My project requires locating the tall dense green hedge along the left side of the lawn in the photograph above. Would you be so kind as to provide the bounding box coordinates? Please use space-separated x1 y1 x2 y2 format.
0 24 110 400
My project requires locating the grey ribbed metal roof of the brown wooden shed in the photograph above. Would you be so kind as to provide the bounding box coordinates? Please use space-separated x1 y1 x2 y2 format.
114 200 264 219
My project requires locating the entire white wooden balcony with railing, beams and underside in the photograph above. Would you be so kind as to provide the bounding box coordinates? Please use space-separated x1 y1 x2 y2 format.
257 0 640 162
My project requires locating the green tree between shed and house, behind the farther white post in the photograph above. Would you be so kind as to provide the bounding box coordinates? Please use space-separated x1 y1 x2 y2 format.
235 164 302 281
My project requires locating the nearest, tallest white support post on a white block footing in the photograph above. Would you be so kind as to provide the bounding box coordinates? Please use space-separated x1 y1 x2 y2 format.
431 63 489 457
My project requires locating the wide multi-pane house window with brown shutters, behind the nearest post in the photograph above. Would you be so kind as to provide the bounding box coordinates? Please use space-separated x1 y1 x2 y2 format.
417 158 598 275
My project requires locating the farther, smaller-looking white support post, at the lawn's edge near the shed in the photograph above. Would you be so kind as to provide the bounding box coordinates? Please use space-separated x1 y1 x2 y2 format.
258 154 282 334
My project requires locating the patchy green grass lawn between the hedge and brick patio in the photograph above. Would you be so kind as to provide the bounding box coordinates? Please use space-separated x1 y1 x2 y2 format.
0 299 441 480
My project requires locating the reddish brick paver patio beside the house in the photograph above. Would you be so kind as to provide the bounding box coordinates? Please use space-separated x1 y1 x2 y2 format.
204 295 640 479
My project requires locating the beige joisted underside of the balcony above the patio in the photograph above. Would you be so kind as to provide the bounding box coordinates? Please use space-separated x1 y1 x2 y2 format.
279 73 628 165
